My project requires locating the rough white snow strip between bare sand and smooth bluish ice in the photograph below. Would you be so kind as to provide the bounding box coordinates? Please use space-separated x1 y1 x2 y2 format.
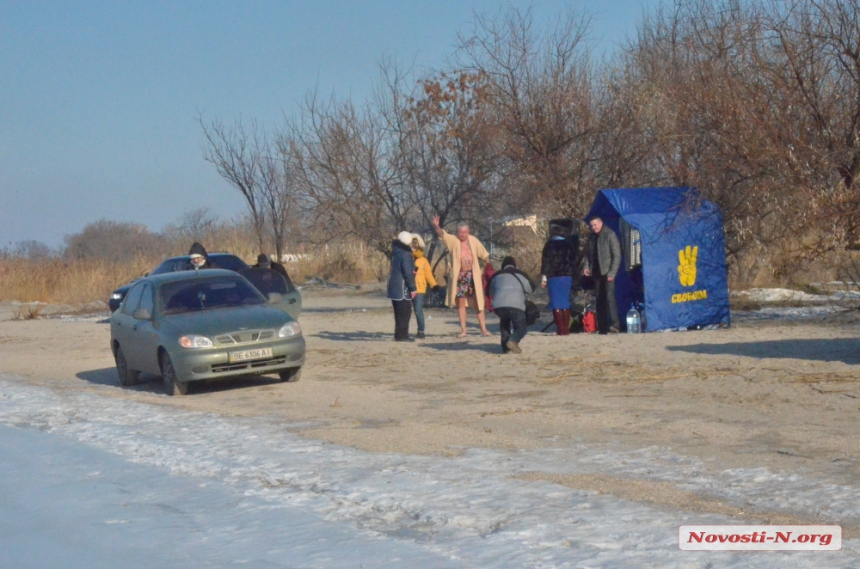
0 376 860 568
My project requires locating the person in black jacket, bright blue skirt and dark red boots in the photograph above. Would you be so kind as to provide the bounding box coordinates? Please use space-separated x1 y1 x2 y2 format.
540 226 578 336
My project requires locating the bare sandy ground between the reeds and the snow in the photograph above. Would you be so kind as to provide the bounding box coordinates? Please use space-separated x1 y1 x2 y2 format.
0 289 860 538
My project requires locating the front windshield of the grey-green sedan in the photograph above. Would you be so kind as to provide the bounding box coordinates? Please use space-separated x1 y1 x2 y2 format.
159 277 266 316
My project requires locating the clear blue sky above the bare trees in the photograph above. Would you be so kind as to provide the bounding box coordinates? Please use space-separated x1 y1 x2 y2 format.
0 0 658 248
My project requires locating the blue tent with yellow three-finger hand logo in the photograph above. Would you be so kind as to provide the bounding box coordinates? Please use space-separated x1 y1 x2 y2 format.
587 188 729 332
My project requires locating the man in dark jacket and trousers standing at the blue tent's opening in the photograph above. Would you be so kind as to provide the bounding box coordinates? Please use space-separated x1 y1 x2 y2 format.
583 217 621 334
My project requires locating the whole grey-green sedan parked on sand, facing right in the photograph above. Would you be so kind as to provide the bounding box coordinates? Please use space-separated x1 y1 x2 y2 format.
110 269 305 395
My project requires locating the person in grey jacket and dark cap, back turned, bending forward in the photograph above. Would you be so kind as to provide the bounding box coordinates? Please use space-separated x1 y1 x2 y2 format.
487 257 534 354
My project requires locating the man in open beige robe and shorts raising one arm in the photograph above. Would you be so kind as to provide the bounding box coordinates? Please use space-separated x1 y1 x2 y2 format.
433 215 491 338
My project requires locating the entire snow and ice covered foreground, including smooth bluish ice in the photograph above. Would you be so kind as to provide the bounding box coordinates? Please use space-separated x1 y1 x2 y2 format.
0 375 860 569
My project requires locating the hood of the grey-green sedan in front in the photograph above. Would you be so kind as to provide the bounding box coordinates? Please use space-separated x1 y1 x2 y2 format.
160 304 293 337
